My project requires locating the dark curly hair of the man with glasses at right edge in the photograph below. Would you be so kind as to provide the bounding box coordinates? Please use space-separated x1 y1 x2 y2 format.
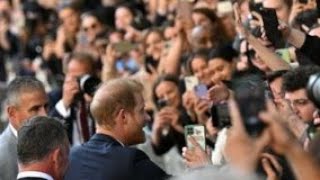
283 65 320 92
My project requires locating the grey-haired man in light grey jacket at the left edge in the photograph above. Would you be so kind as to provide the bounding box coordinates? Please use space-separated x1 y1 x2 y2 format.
0 77 48 180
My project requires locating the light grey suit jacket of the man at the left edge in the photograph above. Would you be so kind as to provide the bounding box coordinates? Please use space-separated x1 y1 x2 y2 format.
0 125 18 180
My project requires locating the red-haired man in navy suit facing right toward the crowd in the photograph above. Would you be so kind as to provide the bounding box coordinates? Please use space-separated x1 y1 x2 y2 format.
65 78 168 180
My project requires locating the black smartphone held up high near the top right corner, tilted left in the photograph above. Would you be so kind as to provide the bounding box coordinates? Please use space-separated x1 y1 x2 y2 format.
259 8 284 49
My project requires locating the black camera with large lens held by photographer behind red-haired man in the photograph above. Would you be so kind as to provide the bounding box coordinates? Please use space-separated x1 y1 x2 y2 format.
78 74 101 97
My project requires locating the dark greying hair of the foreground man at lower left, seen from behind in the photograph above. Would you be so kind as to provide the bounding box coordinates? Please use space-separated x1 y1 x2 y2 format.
17 116 68 165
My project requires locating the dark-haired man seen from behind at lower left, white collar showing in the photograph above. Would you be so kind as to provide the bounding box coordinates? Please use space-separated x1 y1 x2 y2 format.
17 116 69 180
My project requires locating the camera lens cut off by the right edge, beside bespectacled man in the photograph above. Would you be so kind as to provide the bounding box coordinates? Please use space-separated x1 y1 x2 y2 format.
307 73 320 108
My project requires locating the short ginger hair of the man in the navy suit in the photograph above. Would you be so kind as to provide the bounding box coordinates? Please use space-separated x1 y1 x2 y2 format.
90 78 143 127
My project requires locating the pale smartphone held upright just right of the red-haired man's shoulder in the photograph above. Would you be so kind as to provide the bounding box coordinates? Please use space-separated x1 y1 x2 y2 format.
184 125 206 150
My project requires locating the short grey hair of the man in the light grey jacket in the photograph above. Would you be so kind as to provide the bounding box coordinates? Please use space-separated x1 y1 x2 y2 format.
6 76 45 106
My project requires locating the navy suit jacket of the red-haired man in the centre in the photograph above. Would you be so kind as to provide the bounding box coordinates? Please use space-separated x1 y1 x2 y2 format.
65 134 168 180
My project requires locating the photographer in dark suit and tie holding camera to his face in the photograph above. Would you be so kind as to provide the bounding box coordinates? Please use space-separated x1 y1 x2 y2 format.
49 52 95 145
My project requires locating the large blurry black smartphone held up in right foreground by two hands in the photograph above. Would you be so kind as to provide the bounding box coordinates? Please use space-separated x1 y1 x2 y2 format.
233 74 266 137
